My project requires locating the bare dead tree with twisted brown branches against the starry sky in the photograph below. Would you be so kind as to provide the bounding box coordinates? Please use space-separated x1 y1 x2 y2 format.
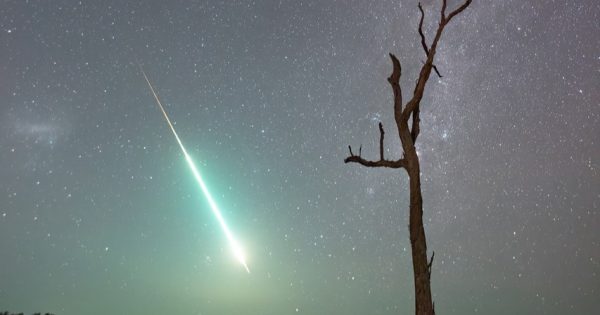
344 0 472 315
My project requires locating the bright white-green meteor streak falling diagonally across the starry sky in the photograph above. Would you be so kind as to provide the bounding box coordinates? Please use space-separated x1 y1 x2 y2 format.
140 66 250 273
